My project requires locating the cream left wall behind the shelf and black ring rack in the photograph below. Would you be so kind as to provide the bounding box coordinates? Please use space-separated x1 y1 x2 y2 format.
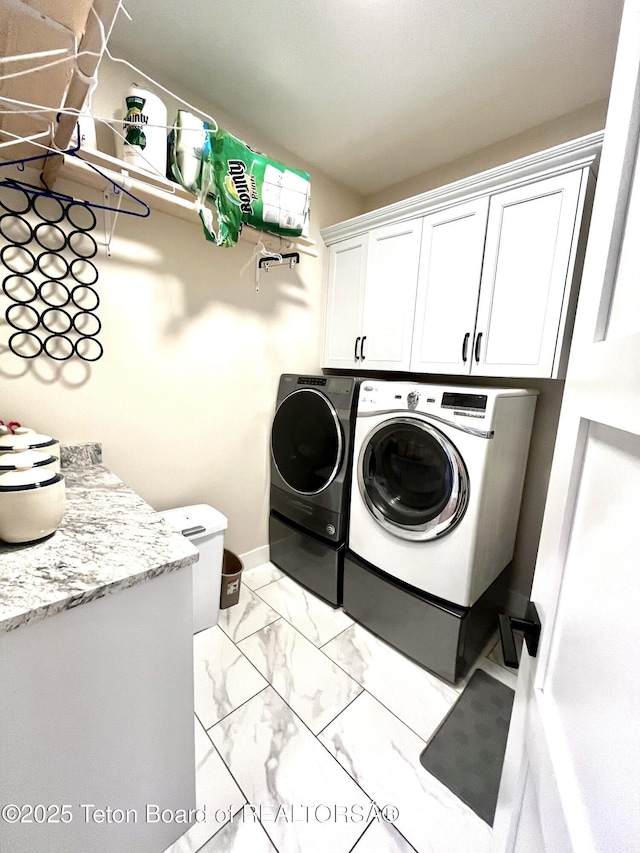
0 58 362 553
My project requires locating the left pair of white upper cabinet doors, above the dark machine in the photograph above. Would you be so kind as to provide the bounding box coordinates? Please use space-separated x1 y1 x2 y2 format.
324 219 422 370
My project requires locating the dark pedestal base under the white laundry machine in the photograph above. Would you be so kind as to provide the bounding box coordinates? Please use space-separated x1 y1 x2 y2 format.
342 551 499 684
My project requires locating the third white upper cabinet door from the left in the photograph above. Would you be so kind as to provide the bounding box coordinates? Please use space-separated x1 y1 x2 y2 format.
411 197 489 374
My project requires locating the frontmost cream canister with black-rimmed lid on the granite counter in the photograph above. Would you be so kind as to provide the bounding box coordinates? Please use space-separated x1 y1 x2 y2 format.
0 468 65 543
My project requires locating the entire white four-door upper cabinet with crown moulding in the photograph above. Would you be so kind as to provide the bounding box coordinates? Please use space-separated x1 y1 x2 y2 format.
322 134 602 378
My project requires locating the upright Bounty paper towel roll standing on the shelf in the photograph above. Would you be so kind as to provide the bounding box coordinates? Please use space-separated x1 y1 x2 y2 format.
122 83 167 175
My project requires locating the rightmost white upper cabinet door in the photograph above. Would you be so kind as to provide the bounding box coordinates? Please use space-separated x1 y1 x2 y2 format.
472 170 586 377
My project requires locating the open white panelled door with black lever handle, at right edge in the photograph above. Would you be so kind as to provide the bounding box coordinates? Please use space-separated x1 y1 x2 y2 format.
494 0 640 853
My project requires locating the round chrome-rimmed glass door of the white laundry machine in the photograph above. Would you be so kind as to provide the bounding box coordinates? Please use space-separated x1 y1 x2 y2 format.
358 417 469 540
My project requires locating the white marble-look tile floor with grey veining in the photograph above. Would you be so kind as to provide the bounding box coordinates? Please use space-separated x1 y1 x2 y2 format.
166 563 516 853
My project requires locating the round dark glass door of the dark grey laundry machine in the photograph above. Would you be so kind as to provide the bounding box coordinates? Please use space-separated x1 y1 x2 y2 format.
271 388 344 495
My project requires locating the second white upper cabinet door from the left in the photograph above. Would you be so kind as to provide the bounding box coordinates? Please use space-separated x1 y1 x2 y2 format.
359 219 422 370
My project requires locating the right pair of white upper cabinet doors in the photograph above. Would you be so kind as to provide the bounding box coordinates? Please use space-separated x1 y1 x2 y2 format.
410 170 587 377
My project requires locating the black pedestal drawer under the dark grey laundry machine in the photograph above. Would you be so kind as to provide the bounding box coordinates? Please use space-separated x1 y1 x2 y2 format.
269 513 344 607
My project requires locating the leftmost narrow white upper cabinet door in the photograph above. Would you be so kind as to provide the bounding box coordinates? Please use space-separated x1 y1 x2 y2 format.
323 234 369 370
